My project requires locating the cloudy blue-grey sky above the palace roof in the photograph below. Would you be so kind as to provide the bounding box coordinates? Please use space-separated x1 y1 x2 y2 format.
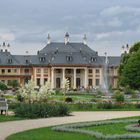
0 0 140 55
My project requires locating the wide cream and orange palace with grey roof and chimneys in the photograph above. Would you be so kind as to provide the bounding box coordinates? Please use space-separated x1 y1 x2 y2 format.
0 33 124 89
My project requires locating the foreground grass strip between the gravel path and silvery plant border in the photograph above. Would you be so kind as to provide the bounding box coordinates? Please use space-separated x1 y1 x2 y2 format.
6 128 96 140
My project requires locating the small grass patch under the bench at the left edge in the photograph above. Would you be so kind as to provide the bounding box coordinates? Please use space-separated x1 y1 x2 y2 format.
0 115 21 122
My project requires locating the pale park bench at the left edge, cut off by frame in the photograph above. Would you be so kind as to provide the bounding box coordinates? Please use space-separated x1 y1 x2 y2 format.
0 98 8 115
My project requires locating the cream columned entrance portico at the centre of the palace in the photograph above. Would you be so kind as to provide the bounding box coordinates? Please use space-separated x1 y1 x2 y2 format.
51 67 87 89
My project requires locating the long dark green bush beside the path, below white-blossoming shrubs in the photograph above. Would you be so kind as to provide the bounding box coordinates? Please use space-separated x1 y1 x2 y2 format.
15 103 69 118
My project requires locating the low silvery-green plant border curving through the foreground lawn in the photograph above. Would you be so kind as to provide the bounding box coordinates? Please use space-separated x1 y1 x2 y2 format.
52 120 140 140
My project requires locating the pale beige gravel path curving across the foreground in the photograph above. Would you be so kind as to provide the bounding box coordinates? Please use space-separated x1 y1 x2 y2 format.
0 111 140 140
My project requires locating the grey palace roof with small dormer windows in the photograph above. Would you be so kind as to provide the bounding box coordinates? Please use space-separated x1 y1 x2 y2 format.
0 42 120 66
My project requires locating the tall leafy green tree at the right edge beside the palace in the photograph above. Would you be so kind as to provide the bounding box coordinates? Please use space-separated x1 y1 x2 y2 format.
119 42 140 89
